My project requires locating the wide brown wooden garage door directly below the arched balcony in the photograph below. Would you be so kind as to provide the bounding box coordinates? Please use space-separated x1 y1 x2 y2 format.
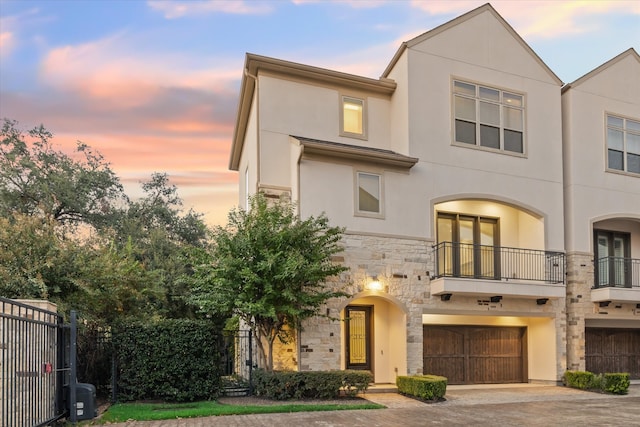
423 325 527 384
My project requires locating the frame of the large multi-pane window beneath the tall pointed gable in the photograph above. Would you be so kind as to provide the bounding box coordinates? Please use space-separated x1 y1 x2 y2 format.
450 77 527 157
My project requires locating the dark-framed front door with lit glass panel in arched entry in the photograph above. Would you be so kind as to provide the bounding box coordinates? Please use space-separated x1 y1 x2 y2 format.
345 305 373 371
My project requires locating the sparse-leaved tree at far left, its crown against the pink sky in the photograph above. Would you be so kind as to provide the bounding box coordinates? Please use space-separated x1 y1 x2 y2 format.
0 119 126 232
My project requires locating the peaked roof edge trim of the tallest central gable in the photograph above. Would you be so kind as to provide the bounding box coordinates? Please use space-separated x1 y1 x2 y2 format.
382 3 562 84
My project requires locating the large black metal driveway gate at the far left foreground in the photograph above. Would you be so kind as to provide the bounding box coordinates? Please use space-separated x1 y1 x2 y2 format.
0 297 69 427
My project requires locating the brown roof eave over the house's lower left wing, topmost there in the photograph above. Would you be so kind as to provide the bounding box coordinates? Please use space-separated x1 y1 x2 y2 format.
229 53 396 170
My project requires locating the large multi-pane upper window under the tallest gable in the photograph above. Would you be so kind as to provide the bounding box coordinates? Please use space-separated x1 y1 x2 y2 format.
453 80 524 154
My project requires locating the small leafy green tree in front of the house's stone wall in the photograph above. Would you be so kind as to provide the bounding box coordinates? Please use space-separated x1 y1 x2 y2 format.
191 194 347 370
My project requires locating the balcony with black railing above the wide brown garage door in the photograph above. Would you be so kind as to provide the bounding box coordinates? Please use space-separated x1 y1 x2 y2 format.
431 242 566 304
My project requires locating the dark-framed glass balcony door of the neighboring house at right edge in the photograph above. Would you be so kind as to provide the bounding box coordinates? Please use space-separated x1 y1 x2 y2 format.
595 230 631 287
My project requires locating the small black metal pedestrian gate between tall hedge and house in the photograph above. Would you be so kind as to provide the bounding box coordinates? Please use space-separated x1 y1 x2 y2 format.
221 330 256 396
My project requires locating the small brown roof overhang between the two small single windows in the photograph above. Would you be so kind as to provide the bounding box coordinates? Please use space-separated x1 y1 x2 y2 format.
291 135 418 169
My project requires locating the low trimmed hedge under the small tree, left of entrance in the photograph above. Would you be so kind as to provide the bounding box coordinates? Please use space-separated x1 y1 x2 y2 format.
253 369 373 400
